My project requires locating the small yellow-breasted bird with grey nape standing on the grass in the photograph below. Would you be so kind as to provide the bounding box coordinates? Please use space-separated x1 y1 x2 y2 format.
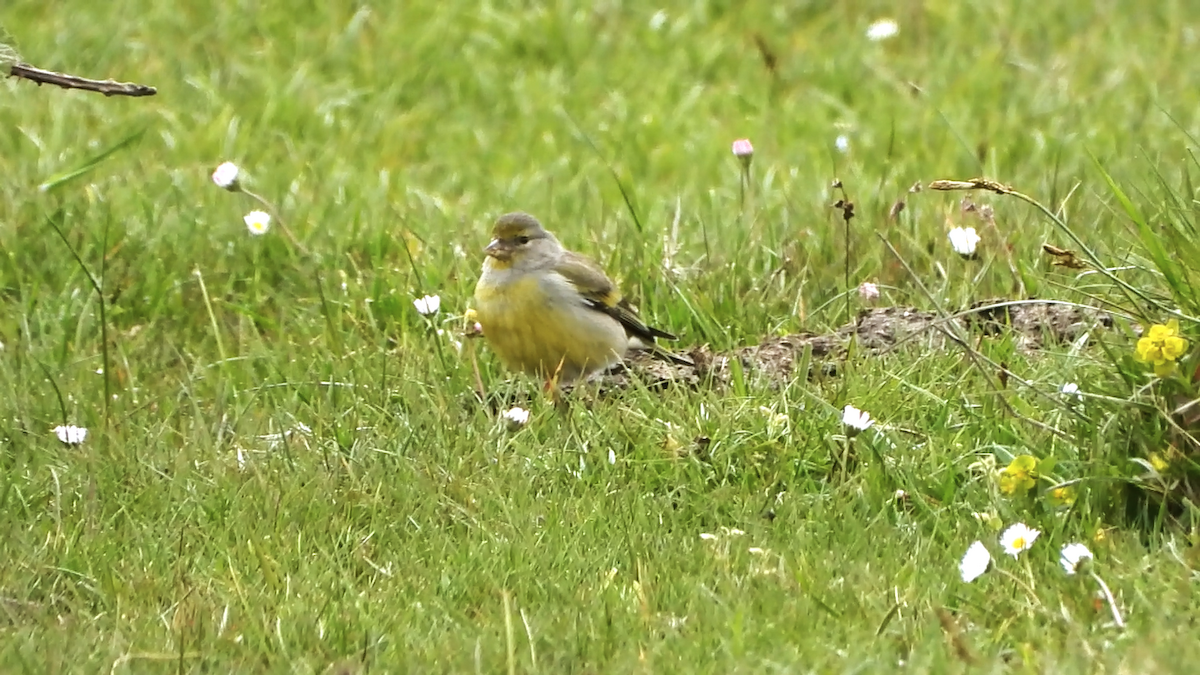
475 213 676 387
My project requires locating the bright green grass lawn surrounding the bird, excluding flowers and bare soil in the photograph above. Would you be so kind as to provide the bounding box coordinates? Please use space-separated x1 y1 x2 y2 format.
0 0 1200 673
